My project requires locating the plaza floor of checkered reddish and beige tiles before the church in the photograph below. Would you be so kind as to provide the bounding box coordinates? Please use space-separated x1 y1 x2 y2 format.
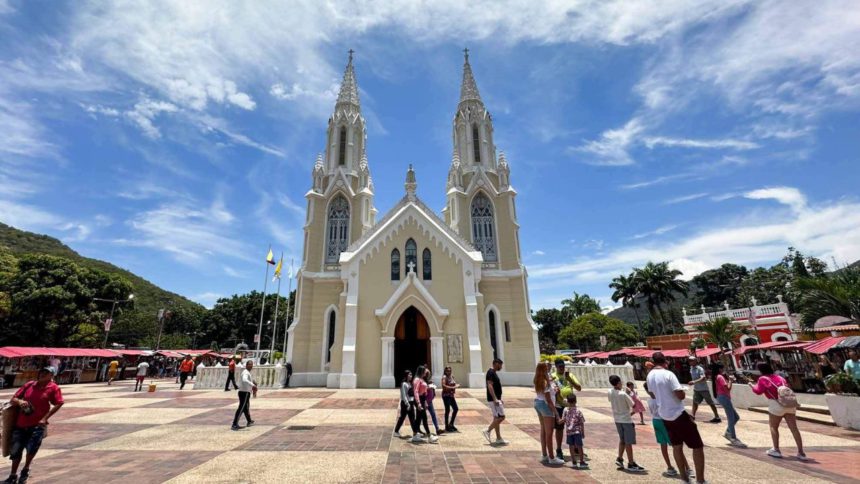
0 380 860 484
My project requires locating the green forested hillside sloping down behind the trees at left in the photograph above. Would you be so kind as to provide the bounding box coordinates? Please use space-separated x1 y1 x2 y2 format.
0 223 206 344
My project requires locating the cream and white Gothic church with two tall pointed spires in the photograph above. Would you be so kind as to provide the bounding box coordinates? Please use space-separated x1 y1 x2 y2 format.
287 52 539 388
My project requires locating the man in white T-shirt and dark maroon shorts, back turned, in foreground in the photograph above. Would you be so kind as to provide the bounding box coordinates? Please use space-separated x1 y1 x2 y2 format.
648 351 706 483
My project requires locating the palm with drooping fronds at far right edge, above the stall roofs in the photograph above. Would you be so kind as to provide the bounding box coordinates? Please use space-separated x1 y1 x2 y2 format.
797 266 860 326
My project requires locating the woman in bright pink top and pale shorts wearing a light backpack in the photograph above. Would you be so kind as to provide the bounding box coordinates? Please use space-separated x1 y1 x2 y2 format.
749 363 809 462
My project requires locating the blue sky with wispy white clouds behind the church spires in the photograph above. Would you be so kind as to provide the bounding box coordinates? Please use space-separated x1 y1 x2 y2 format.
0 0 860 309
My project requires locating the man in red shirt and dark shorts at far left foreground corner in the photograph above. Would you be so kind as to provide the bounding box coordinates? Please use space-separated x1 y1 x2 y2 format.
3 366 63 484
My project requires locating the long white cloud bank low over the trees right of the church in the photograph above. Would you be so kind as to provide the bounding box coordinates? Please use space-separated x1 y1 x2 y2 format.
529 187 860 287
